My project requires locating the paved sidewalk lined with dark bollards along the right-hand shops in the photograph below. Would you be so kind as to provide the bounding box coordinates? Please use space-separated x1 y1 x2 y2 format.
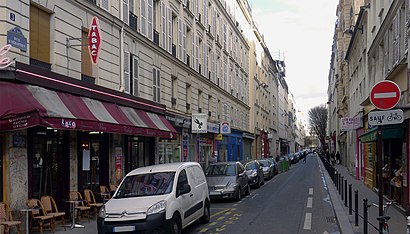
319 159 407 234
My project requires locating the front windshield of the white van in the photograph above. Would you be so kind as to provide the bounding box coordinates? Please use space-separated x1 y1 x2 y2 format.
114 172 175 199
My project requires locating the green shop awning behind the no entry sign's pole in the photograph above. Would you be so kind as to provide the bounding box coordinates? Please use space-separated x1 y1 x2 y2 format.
359 124 404 143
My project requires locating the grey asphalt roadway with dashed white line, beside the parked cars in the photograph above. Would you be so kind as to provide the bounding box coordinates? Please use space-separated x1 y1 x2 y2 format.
183 154 339 234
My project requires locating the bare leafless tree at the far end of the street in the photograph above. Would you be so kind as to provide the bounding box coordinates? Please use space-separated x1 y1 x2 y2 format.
308 105 327 150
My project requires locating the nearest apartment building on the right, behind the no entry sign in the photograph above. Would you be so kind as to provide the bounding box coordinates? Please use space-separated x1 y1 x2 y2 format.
334 1 410 209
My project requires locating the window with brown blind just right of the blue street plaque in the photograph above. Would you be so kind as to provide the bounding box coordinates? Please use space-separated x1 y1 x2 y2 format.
30 5 50 64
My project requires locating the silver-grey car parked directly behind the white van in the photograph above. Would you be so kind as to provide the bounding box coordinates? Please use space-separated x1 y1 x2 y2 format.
205 162 251 201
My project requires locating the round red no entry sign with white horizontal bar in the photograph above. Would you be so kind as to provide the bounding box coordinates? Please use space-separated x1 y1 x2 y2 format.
370 80 401 110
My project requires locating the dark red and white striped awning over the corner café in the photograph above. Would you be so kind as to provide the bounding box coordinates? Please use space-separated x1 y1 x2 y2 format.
0 82 176 138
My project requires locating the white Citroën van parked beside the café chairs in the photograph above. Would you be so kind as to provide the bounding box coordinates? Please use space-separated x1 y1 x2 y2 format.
97 162 210 233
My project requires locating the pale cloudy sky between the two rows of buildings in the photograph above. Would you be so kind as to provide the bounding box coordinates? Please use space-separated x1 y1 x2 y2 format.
248 0 338 116
